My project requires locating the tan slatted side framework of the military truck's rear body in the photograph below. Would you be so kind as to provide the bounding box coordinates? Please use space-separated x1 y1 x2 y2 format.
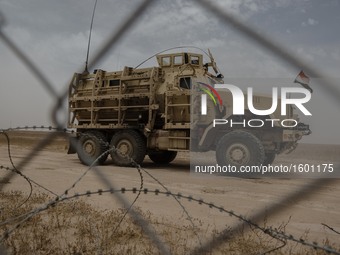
68 67 161 129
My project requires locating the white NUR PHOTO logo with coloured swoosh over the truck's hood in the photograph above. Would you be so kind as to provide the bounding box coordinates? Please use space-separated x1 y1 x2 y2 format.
198 73 312 127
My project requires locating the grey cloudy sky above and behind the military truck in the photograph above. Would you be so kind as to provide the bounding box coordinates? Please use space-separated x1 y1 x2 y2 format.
0 0 340 142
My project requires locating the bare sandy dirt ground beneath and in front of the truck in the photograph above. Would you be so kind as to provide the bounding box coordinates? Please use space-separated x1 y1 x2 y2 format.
0 131 340 253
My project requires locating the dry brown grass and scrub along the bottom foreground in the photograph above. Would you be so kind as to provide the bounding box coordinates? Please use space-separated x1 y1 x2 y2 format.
0 191 338 255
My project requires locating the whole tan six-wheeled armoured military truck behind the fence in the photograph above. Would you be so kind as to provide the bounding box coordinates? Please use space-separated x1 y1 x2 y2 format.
68 51 310 166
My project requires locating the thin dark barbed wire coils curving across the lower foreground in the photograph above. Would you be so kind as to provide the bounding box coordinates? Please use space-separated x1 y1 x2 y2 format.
0 126 340 254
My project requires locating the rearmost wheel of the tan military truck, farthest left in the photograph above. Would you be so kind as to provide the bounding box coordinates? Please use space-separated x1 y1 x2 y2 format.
77 131 109 166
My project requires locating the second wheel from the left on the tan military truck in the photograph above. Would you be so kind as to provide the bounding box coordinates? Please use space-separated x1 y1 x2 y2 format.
110 130 146 166
